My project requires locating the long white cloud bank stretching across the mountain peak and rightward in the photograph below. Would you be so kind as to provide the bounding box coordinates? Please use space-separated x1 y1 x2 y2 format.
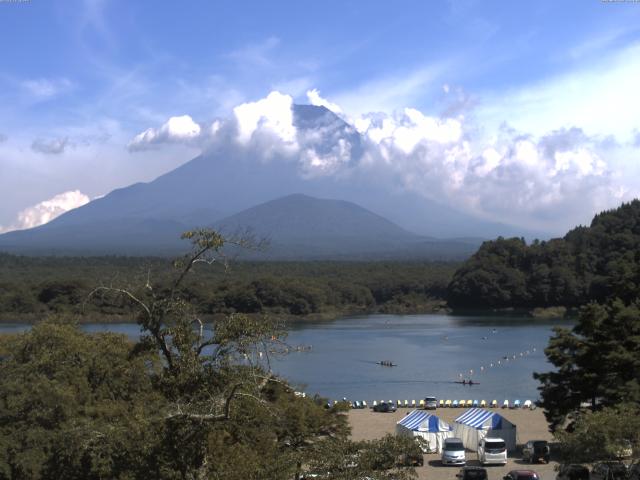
130 90 626 233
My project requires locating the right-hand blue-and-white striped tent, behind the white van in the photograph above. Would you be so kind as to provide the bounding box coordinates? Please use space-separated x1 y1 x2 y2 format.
454 408 516 451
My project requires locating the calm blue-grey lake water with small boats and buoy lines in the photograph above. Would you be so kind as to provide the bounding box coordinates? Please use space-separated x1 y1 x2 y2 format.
0 314 570 403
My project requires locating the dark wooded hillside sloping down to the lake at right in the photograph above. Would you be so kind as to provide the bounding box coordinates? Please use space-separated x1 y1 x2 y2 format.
447 200 640 308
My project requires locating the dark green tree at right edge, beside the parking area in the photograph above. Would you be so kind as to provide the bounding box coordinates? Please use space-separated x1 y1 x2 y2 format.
534 300 640 430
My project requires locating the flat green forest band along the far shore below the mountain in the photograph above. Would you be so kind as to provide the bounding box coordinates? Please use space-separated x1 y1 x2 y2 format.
0 254 459 321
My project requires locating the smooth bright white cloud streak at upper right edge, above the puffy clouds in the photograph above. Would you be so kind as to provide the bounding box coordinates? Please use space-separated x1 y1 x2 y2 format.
476 44 640 141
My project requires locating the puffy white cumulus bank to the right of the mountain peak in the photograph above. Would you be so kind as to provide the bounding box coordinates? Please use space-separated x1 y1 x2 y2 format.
350 109 620 228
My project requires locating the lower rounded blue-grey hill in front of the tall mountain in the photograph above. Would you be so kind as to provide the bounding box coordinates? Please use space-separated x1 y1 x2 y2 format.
213 194 481 259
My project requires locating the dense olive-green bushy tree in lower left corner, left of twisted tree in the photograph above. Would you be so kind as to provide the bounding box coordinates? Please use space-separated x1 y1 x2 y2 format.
0 323 164 479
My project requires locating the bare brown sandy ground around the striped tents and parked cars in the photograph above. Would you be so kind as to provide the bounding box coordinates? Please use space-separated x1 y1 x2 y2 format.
348 408 557 480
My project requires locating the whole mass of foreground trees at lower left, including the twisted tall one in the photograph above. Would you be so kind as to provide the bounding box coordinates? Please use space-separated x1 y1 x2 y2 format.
0 230 415 480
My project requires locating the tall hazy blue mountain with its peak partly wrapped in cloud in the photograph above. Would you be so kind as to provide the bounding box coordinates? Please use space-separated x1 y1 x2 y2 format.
0 105 533 258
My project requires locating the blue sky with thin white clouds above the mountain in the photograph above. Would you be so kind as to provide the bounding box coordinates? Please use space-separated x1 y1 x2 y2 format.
0 0 640 230
